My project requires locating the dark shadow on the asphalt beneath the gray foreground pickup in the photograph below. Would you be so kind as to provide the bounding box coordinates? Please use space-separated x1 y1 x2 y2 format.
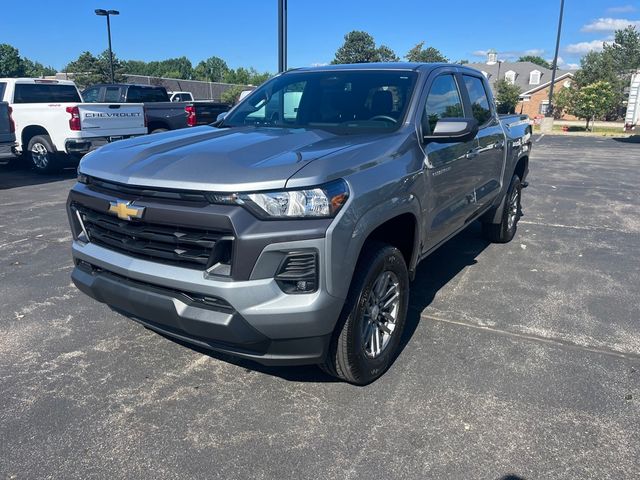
163 222 490 382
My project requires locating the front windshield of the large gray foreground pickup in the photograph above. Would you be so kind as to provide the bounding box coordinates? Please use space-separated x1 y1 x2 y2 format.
224 70 417 134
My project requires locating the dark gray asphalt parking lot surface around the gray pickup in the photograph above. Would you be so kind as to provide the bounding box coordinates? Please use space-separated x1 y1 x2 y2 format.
0 136 640 479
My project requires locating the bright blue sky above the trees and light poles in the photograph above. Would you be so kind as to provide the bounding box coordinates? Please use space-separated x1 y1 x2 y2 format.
0 0 640 72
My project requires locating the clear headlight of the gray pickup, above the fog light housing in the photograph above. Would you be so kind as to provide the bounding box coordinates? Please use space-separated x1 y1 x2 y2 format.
238 180 349 218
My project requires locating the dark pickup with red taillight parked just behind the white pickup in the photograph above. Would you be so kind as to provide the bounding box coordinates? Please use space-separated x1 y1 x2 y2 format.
82 83 231 133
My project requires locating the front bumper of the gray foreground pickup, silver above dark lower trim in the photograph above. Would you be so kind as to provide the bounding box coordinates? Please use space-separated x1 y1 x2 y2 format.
72 239 343 365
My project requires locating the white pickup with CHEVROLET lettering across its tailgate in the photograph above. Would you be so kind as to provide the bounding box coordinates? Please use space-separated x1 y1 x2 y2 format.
0 78 147 172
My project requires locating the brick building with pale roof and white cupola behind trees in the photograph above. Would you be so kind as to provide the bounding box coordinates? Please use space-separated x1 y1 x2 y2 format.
469 50 575 120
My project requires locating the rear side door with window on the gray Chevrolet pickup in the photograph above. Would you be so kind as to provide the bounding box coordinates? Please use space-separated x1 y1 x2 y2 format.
462 73 505 208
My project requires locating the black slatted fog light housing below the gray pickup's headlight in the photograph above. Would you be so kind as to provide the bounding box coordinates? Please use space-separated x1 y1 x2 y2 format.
275 250 318 295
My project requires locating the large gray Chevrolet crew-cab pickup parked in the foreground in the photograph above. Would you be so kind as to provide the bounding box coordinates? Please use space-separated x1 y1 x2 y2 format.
67 63 531 385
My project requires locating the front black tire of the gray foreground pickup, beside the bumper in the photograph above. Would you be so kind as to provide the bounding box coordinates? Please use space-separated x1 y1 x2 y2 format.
320 242 409 385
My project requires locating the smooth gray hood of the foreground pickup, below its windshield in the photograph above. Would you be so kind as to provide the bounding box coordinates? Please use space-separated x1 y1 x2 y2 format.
80 126 366 192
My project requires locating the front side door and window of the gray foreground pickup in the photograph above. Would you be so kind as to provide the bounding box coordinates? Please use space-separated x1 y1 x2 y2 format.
422 71 476 250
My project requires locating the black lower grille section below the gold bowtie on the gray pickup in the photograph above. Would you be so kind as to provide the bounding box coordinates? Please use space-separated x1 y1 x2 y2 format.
73 205 233 270
